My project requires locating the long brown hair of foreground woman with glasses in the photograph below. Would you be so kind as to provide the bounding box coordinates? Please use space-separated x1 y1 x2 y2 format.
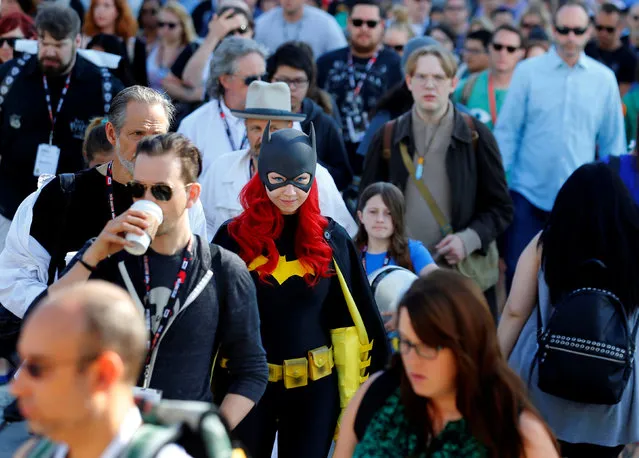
394 269 559 458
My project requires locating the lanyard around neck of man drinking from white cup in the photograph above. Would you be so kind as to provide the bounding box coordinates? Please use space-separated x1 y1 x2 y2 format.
143 238 193 381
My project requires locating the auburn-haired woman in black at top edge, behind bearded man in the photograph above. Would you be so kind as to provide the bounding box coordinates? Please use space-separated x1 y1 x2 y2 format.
82 0 148 86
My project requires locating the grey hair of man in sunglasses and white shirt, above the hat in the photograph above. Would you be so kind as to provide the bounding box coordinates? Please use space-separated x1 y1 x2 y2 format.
206 37 268 99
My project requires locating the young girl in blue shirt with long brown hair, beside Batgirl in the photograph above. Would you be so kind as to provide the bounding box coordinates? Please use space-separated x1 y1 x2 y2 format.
355 182 437 275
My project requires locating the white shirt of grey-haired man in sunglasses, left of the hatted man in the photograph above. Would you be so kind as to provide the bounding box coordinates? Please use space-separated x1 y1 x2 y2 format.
178 97 248 178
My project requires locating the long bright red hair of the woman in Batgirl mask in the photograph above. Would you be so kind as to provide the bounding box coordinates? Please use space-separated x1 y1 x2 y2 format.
228 175 333 286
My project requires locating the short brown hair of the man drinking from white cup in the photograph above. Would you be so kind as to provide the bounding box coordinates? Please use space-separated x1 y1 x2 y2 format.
135 132 202 183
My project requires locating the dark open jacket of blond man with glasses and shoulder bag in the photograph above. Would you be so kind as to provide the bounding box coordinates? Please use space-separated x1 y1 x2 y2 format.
360 108 513 249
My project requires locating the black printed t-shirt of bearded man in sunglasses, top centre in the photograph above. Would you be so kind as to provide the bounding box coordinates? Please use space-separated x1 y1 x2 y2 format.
317 48 402 174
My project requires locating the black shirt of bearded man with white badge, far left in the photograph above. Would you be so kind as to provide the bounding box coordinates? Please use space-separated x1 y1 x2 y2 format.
0 56 123 219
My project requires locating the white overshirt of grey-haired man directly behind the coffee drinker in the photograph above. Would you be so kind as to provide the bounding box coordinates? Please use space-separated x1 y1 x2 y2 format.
0 177 209 318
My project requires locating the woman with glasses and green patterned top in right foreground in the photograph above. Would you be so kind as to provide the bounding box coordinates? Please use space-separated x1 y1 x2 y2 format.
333 269 559 458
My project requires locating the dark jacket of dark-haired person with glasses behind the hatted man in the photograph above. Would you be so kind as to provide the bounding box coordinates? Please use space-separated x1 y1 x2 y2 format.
301 98 353 191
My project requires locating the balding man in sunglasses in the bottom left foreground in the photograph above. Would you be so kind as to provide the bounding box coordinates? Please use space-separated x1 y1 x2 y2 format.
11 280 190 458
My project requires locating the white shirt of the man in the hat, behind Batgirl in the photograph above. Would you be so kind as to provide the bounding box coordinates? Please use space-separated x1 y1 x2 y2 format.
200 149 357 237
